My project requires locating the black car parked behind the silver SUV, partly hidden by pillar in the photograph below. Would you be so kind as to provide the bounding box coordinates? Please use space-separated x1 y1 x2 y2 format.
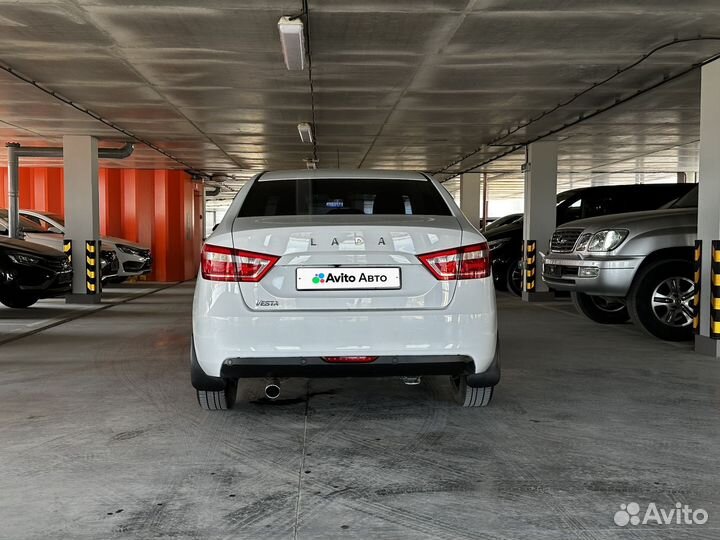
485 184 695 295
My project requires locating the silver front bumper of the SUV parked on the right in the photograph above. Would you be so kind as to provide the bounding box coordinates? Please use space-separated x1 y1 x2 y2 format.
542 255 642 297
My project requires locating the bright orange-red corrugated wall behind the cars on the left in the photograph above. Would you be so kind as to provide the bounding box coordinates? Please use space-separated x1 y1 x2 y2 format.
0 167 202 281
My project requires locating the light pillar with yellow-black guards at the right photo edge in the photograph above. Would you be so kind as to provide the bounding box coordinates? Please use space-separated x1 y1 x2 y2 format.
695 60 720 358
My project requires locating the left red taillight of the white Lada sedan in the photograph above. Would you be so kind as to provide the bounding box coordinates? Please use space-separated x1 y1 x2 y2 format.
200 244 280 283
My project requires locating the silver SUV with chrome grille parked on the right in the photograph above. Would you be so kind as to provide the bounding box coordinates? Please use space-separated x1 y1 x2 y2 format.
542 189 698 341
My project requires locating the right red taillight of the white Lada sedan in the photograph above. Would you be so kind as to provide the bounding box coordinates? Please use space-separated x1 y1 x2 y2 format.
418 242 490 280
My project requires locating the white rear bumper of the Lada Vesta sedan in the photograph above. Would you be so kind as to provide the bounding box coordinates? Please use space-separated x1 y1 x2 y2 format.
193 278 497 377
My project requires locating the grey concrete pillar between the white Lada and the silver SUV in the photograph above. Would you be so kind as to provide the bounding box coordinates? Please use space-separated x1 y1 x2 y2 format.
523 141 558 302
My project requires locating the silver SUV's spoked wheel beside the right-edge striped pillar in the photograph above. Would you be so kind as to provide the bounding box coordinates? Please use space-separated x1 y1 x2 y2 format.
627 259 695 341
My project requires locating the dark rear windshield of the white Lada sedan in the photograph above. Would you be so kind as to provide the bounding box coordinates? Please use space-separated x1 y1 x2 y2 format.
238 178 452 217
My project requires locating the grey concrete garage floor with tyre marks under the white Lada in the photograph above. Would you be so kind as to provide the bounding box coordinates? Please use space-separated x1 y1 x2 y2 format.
0 284 720 540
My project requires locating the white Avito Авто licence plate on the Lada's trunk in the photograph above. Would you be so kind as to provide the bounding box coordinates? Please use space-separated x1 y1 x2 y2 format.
295 266 402 291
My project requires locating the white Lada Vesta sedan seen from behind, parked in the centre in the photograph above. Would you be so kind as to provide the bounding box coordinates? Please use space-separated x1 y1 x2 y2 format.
191 169 500 409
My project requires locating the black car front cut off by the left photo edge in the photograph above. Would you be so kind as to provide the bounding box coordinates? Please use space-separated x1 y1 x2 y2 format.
0 238 72 308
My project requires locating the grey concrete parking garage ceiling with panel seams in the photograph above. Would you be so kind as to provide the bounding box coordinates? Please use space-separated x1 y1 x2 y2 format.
0 0 720 198
